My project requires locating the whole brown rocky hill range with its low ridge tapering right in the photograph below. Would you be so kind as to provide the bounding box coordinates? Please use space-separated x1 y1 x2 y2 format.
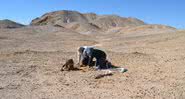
31 10 175 34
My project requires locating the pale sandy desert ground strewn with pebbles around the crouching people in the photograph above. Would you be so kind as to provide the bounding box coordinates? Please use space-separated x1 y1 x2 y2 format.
0 26 185 99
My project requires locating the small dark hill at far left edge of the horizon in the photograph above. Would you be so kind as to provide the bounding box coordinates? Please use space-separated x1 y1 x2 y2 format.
0 19 24 28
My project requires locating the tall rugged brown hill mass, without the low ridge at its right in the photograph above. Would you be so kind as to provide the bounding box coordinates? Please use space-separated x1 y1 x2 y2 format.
31 10 145 30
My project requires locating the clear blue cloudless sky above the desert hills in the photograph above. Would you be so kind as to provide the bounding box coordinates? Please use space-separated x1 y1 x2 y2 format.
0 0 185 28
